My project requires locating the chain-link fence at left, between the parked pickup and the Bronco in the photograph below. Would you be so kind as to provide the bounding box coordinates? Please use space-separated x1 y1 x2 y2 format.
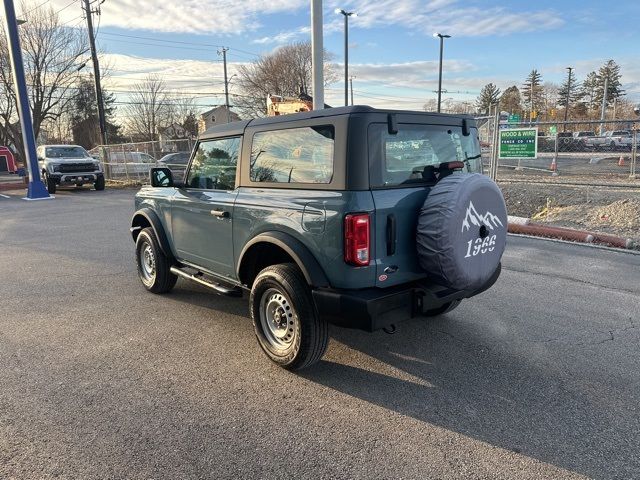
89 139 195 183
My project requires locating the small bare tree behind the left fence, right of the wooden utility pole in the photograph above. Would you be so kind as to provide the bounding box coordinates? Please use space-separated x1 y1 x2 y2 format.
125 75 175 141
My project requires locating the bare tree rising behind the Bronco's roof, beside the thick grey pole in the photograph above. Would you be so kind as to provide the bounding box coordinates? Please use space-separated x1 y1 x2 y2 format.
235 42 337 117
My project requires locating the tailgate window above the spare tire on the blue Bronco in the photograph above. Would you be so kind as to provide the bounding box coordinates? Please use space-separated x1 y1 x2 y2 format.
369 123 482 188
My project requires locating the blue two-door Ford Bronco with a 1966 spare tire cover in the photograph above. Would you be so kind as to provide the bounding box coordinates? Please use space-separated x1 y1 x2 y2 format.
131 106 507 369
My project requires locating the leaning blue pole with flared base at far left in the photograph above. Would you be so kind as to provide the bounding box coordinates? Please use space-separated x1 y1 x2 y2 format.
4 0 53 200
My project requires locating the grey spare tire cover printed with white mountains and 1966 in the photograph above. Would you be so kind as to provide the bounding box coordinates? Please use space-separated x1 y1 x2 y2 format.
416 173 507 290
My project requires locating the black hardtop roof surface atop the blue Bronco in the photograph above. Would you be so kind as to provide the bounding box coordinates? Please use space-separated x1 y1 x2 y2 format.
200 105 473 139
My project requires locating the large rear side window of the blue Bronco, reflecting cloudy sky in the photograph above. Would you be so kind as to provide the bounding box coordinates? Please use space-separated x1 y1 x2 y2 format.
249 125 335 184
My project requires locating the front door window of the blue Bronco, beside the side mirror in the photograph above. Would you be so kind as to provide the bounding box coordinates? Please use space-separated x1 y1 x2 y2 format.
187 137 240 190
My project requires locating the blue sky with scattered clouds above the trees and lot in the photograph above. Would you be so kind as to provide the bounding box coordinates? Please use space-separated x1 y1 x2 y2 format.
20 0 640 108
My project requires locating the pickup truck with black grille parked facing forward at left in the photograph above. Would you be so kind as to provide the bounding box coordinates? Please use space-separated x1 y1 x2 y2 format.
36 145 105 194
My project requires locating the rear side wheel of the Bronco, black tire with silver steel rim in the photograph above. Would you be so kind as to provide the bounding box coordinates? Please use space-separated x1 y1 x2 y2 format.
249 263 329 370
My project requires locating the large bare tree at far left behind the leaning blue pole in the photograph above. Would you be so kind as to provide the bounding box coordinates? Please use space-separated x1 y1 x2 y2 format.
0 4 88 158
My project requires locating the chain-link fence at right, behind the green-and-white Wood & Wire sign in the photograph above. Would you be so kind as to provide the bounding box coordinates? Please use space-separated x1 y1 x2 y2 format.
476 115 640 186
